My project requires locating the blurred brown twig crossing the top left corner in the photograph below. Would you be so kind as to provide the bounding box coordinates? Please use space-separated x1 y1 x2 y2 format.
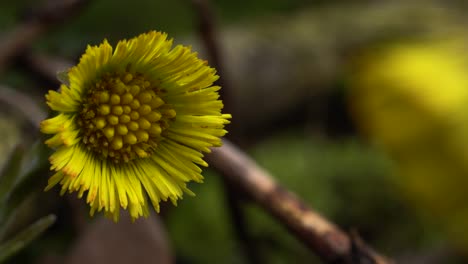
0 0 89 71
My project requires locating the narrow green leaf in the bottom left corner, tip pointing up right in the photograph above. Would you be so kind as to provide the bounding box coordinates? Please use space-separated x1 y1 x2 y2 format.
0 215 56 263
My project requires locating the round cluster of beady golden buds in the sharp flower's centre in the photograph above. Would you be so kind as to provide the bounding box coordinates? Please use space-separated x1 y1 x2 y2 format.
78 73 176 163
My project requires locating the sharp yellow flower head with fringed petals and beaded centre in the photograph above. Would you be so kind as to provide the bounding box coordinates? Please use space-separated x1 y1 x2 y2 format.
41 31 231 221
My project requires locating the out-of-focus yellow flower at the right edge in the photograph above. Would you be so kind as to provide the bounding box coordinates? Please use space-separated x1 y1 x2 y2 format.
350 41 468 250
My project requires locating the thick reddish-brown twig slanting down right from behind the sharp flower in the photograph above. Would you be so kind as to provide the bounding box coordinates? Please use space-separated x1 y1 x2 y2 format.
207 141 392 264
